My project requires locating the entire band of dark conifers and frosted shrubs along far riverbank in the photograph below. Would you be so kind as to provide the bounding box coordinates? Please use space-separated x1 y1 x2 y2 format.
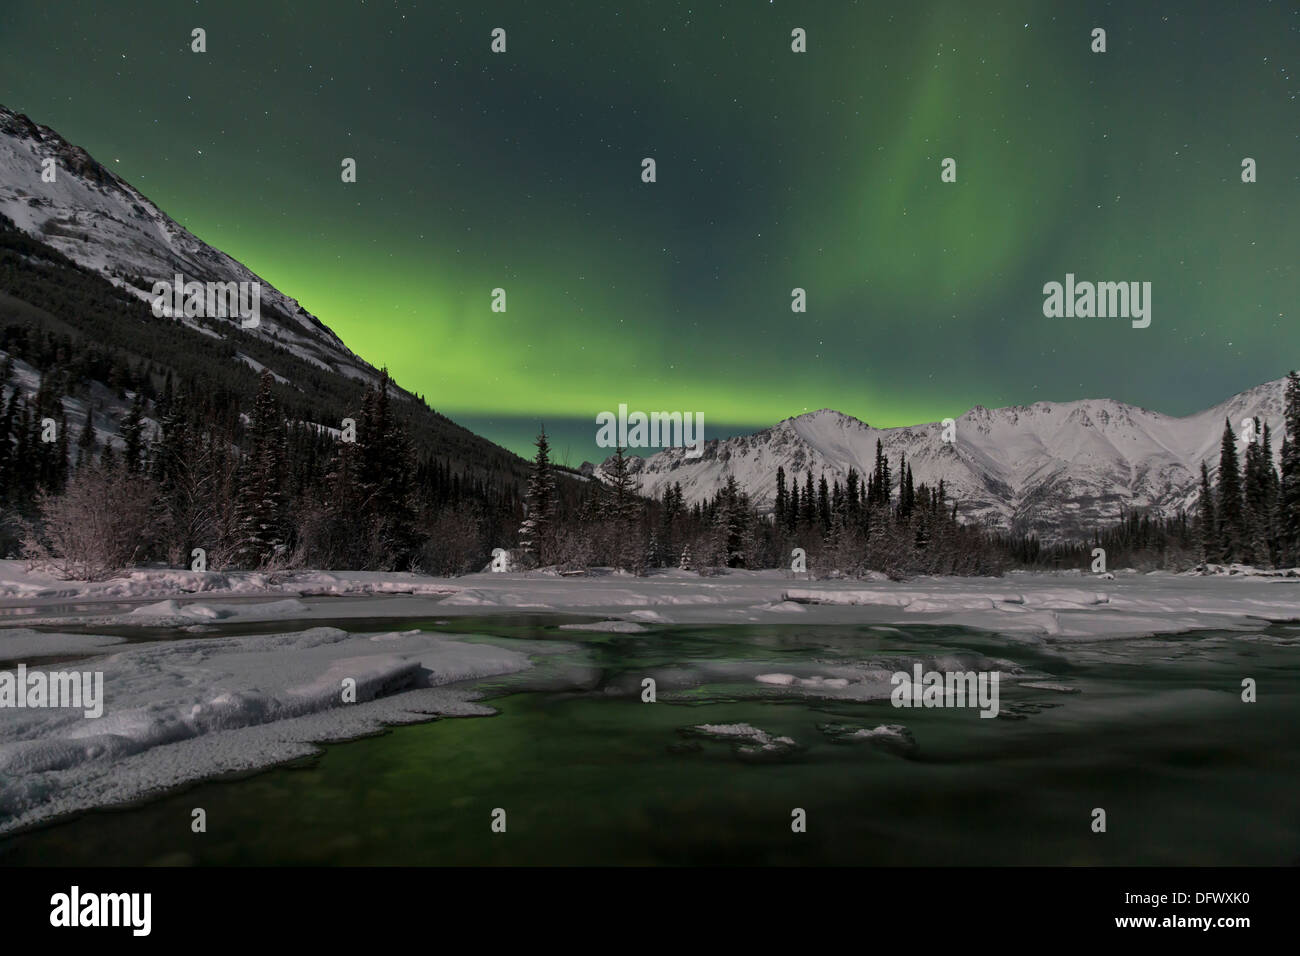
10 356 1300 579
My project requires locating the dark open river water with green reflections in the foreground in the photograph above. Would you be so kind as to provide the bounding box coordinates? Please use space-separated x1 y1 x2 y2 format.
0 615 1300 865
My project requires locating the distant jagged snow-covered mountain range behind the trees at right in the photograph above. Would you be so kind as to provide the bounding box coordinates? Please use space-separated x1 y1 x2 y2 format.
594 378 1286 540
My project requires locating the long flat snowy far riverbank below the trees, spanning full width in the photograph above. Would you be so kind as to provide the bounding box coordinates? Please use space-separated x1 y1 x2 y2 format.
0 561 1300 643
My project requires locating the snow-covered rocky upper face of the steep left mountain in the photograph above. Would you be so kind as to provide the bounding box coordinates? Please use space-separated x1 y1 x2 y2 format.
0 105 377 382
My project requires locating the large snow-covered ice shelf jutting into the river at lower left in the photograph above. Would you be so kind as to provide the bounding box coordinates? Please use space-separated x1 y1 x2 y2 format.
0 627 529 831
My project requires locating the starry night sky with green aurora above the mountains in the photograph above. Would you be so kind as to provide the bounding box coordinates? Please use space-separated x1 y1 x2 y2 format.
0 0 1300 464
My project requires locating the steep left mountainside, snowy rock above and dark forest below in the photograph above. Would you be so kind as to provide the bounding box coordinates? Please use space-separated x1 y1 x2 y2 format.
0 107 540 483
